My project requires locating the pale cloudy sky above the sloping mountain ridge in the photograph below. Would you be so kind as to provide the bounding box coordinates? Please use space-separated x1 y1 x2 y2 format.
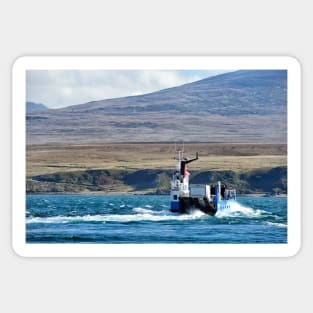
26 70 227 108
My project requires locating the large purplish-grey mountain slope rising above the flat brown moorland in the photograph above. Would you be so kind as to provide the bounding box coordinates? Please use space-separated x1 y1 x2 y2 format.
27 70 287 143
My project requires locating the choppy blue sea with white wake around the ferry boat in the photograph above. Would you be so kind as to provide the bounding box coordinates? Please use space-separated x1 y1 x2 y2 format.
26 195 287 244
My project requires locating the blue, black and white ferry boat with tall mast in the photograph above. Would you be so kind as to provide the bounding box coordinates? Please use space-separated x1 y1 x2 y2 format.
170 149 236 215
